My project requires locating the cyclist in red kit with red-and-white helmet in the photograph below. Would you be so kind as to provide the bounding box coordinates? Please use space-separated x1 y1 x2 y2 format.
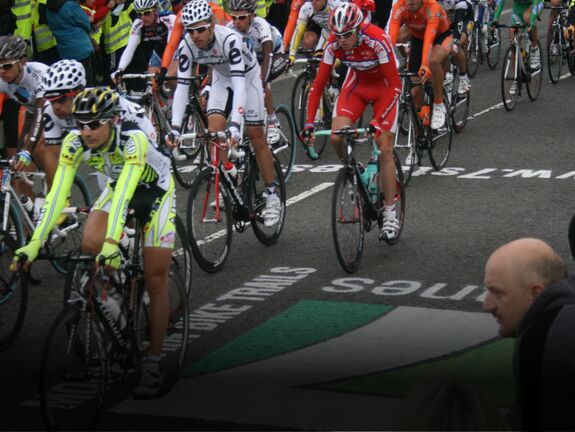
302 3 401 240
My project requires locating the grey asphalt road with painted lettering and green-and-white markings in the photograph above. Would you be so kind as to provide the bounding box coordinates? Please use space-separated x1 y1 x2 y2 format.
0 12 575 430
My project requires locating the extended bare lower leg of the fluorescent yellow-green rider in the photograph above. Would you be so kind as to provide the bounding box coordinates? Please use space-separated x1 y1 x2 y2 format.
144 247 172 356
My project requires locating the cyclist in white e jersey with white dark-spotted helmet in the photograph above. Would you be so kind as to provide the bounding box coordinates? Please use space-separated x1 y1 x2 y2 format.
168 0 281 227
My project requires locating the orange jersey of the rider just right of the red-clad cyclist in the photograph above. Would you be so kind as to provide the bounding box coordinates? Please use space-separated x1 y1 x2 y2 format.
389 0 451 67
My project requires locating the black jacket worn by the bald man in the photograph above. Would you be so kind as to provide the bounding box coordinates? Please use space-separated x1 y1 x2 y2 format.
514 278 575 430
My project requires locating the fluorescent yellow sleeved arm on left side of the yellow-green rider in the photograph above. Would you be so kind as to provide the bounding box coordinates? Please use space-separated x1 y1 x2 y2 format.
28 132 83 242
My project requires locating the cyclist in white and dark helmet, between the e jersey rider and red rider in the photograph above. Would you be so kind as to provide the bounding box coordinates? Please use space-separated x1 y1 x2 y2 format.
227 0 284 144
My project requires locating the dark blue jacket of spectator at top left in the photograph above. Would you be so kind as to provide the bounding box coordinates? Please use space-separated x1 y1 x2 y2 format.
46 0 94 61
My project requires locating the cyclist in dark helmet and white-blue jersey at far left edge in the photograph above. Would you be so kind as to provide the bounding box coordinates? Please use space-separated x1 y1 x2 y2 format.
0 36 53 196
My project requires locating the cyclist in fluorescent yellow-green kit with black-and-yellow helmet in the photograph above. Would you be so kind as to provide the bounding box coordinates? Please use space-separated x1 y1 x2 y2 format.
14 88 176 397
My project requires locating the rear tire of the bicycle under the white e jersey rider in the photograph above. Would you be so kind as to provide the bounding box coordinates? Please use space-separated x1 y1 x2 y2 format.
252 157 286 246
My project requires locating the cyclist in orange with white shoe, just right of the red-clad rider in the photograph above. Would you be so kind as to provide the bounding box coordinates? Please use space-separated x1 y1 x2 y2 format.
389 0 453 129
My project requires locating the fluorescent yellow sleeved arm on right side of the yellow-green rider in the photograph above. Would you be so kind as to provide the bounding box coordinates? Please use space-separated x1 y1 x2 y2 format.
105 131 150 243
